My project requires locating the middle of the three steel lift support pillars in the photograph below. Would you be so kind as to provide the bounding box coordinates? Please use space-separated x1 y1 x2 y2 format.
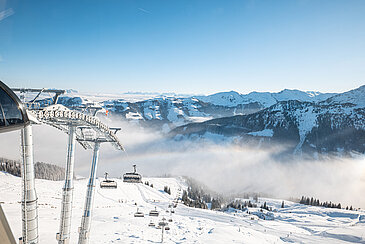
56 124 76 244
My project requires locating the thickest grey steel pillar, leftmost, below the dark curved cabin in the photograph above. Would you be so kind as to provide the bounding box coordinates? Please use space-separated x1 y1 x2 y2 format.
20 125 38 244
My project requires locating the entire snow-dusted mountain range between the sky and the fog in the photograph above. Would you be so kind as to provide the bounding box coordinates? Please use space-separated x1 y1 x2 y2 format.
53 86 365 155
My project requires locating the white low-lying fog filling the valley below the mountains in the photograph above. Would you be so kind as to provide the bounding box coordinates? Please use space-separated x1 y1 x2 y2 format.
0 121 365 208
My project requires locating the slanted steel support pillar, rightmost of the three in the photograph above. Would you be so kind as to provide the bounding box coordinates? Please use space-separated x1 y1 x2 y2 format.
78 141 100 244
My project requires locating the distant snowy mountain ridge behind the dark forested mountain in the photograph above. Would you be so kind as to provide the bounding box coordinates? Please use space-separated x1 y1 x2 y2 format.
54 89 336 128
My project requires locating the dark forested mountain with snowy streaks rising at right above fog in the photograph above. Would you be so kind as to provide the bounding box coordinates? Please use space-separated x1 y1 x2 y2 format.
171 86 365 154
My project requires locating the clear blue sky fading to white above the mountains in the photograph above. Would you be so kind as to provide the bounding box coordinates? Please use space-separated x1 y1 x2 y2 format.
0 0 365 93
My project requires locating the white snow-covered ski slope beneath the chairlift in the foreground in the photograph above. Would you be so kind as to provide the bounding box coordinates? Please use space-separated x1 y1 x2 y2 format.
0 172 365 244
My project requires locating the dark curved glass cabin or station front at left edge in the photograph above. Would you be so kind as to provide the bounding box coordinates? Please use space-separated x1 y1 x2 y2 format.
0 81 30 132
